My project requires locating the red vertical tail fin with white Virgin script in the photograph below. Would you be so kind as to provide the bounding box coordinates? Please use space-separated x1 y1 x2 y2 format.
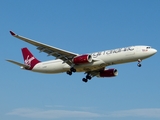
22 48 40 70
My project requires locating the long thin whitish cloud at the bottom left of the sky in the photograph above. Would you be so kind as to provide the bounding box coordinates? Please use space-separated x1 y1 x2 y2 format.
7 108 101 119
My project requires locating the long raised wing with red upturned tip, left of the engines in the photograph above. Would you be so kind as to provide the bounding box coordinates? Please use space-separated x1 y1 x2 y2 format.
10 31 78 65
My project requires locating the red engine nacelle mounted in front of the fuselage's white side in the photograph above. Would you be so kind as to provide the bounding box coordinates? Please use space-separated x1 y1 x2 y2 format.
72 55 92 64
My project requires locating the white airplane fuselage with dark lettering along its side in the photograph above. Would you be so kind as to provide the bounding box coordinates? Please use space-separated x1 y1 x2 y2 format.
32 46 157 74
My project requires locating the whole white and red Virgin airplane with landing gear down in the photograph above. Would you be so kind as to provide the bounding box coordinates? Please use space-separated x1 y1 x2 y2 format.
7 31 157 82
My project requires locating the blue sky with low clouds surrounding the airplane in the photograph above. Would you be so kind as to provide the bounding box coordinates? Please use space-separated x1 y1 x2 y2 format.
0 0 160 120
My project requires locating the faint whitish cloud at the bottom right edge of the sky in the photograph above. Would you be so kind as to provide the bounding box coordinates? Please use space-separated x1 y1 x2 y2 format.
106 108 160 118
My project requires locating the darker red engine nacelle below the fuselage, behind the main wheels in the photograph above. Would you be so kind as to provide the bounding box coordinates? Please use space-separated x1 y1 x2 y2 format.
99 69 118 77
